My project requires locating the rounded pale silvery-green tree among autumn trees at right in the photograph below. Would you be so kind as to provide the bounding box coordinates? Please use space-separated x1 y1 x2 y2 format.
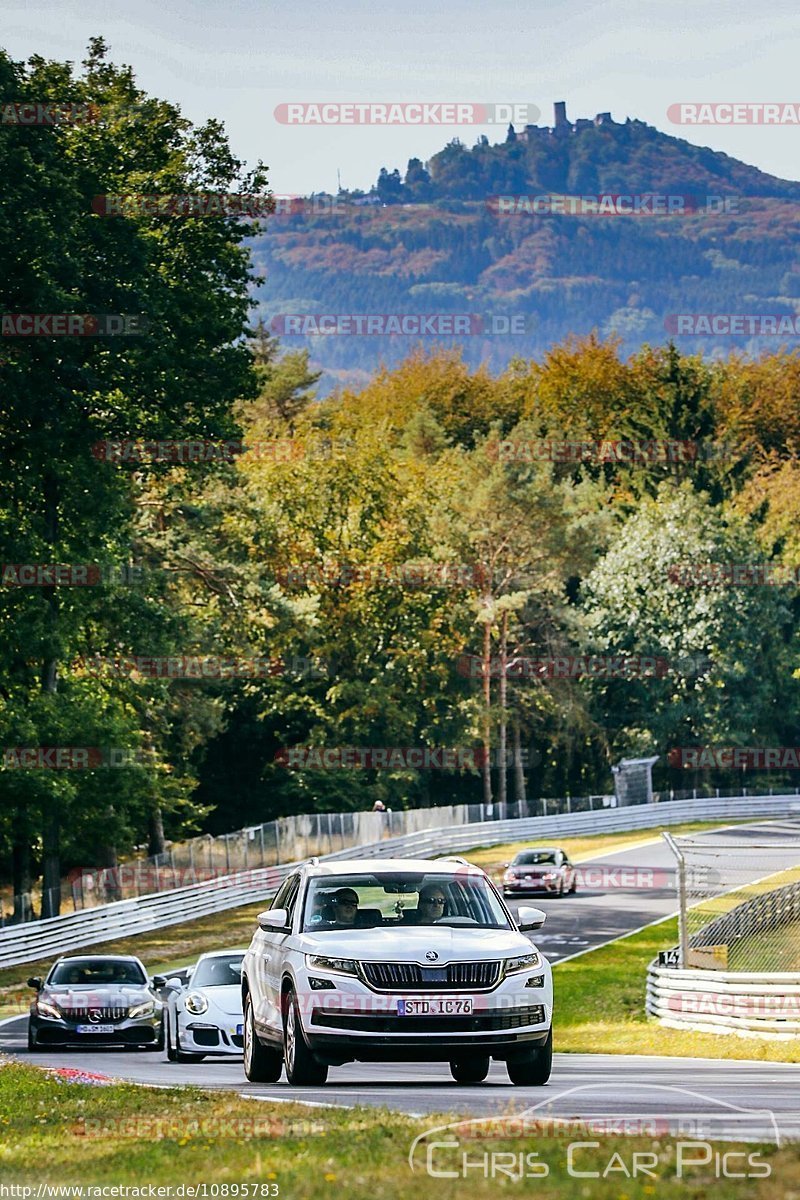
582 482 800 787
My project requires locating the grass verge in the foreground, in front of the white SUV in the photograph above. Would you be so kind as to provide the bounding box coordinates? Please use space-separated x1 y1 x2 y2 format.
0 1062 800 1200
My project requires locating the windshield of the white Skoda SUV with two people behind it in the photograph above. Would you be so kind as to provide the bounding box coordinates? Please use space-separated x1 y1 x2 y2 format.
302 871 512 934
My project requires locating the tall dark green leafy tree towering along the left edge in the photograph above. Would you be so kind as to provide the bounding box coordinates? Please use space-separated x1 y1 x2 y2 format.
0 38 265 914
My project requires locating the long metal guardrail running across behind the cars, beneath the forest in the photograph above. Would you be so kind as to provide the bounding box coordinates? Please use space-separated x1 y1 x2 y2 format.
0 796 800 968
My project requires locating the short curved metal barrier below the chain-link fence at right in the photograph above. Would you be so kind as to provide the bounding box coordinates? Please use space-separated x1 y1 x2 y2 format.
646 961 800 1038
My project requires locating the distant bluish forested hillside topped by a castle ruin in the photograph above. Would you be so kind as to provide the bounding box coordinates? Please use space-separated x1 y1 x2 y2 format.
255 109 800 389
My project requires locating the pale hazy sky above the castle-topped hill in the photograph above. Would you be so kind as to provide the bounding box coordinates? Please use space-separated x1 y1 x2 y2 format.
0 0 800 193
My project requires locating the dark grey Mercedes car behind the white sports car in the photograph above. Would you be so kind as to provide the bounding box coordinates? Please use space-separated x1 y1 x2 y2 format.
28 954 164 1051
